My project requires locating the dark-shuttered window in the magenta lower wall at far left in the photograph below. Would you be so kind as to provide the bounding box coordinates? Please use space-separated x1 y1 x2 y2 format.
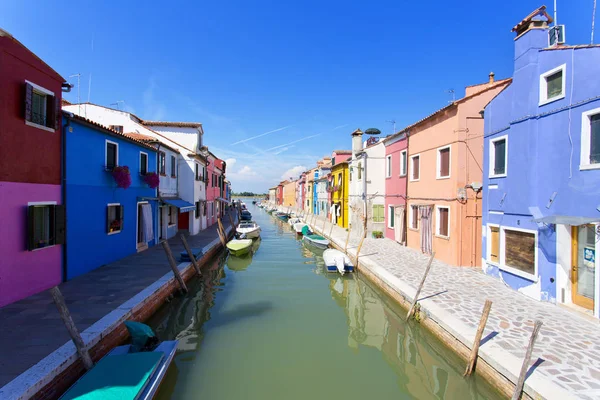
27 202 66 251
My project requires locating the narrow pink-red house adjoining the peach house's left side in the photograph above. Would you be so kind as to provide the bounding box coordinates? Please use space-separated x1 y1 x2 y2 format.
383 132 408 244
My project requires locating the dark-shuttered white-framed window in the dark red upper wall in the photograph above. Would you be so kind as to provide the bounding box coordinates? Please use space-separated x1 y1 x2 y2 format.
25 81 60 132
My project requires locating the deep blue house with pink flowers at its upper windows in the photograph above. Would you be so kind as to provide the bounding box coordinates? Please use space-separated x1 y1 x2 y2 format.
63 112 158 279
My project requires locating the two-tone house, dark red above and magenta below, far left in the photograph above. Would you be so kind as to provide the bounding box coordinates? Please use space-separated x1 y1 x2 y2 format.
0 29 70 307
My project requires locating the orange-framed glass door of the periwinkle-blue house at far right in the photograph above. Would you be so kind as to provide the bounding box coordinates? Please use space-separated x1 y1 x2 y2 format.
571 225 596 310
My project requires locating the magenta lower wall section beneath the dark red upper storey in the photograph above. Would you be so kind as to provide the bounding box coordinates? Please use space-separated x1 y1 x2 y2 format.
0 182 62 307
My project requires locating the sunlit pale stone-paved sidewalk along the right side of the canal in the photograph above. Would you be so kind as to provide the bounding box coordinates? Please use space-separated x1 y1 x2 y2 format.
308 211 600 399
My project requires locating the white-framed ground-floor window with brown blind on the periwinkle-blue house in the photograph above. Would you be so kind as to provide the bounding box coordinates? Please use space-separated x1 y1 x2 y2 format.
500 228 536 276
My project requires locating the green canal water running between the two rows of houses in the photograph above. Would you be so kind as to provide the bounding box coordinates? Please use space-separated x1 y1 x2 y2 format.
150 200 501 400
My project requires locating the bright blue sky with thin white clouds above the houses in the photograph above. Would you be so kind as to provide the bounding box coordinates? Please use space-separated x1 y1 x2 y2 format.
0 0 600 191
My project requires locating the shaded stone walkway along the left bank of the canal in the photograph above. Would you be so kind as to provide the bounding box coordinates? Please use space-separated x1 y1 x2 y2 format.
0 211 237 391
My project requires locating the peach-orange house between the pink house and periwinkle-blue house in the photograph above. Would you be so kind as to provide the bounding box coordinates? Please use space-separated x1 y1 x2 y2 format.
401 73 511 266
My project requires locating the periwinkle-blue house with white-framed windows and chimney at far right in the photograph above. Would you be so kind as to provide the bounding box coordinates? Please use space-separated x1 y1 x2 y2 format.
482 7 600 317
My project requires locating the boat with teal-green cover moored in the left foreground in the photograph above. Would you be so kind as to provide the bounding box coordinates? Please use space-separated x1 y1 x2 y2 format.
60 321 179 400
